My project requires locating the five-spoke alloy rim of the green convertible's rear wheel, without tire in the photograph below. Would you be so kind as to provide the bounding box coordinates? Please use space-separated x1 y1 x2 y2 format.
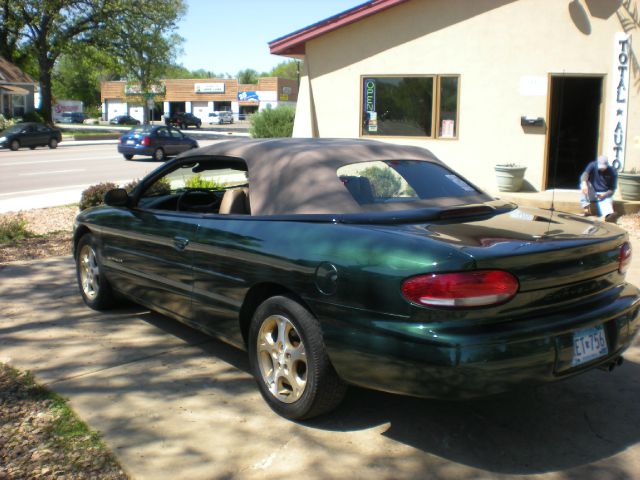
257 315 307 403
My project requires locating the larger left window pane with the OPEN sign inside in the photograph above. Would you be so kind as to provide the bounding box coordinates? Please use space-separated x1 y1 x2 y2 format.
362 77 434 137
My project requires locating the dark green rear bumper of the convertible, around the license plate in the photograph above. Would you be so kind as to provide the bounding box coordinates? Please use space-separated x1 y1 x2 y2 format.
312 284 640 399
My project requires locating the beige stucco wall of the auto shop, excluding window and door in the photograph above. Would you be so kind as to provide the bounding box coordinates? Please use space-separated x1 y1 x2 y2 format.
294 0 640 190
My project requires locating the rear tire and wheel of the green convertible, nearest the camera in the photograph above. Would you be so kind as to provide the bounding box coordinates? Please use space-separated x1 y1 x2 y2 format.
248 296 346 420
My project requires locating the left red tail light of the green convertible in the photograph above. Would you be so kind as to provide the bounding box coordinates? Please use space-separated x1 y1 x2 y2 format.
402 270 519 308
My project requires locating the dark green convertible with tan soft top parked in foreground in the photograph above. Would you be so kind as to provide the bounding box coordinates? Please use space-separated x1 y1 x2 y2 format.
74 139 640 419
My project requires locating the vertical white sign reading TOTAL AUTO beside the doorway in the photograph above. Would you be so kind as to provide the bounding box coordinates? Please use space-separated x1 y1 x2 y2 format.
607 32 631 171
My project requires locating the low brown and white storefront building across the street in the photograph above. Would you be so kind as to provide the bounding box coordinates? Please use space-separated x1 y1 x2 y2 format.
101 77 298 124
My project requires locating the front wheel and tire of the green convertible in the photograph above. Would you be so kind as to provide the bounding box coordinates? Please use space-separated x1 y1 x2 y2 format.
76 233 115 310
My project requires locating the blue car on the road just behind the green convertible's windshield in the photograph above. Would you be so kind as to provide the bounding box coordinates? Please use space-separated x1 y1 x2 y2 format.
118 125 198 162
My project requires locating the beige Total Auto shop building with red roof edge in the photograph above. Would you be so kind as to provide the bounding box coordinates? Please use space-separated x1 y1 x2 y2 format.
269 0 640 191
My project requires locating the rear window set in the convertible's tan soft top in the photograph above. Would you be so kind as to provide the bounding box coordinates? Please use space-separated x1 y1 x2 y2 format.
337 160 489 205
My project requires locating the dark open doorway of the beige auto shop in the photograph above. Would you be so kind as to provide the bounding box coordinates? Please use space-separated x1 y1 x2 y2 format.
545 75 602 189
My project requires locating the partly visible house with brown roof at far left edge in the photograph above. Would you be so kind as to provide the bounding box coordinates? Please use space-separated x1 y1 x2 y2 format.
0 57 36 118
